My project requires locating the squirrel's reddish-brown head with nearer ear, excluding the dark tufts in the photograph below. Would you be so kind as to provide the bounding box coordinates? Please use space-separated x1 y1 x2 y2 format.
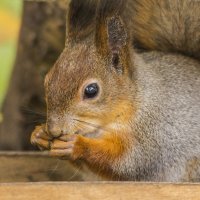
45 2 135 137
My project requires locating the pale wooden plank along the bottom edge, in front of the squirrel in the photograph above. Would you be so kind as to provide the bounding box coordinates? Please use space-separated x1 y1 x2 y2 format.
0 182 200 200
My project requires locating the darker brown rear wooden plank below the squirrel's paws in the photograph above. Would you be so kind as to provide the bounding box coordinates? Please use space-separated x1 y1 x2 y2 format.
0 152 82 183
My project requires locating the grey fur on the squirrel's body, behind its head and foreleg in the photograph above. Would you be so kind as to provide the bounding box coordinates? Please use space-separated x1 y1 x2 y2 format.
112 52 200 182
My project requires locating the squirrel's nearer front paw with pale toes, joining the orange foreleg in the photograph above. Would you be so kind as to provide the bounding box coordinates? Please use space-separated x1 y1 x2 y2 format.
50 135 84 160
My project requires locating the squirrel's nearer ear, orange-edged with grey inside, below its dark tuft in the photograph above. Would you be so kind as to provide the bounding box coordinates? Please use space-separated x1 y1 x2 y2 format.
96 16 130 73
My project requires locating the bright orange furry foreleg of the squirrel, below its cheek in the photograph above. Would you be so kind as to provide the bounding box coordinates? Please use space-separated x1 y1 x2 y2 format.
72 133 129 177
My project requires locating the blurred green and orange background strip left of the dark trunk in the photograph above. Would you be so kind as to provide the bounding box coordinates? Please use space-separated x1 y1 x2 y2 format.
0 0 23 112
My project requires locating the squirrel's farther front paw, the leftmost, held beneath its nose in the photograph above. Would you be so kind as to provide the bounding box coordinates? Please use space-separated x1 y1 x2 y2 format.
31 125 52 150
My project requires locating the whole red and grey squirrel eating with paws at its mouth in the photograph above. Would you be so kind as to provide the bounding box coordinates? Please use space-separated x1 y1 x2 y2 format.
31 0 200 182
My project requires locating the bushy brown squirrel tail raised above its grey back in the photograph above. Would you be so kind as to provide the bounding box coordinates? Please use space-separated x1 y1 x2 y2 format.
123 0 200 59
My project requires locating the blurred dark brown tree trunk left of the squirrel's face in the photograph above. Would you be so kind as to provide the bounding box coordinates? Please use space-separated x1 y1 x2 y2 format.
0 0 68 150
